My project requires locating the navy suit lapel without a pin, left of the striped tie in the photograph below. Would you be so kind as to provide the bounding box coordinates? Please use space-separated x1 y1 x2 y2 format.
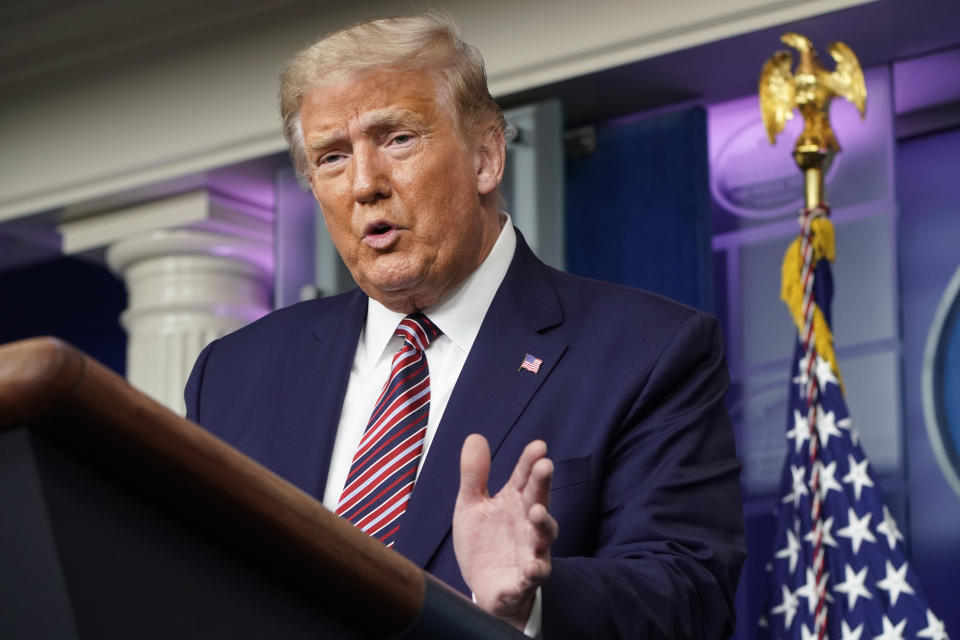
274 289 367 500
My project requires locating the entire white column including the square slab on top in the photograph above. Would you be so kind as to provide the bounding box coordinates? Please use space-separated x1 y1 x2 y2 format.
58 189 274 415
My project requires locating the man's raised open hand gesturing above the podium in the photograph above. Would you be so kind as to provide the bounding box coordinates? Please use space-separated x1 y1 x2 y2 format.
453 434 557 629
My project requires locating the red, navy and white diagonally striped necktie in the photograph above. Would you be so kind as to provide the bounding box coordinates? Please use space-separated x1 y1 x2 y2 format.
337 312 443 547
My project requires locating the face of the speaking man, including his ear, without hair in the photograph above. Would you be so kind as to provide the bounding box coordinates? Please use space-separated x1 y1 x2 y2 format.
300 69 503 313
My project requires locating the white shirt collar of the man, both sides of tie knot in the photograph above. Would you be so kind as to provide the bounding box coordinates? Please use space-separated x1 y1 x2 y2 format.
356 214 517 369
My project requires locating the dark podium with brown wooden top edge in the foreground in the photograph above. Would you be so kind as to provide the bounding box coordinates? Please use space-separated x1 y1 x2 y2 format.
0 338 523 640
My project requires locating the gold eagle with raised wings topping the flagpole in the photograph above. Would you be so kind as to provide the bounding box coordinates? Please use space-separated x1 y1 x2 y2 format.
760 33 867 155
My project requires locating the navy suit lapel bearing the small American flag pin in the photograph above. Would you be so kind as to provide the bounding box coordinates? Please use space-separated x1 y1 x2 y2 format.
394 232 566 567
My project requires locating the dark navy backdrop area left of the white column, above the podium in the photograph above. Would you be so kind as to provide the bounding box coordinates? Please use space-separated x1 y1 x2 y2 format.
0 258 127 375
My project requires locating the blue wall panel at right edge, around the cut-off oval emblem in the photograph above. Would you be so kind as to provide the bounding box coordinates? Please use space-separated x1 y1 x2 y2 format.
897 129 960 638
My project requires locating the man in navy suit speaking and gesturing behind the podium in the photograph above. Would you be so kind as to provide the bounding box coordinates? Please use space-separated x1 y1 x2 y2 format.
186 15 744 638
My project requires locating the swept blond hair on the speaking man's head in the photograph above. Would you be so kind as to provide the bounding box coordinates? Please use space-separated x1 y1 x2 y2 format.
279 12 506 180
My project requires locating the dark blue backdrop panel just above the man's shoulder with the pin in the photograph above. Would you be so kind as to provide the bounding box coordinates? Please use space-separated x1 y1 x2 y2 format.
566 107 713 310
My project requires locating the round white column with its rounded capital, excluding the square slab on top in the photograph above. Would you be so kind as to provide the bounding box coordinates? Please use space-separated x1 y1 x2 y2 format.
107 229 272 415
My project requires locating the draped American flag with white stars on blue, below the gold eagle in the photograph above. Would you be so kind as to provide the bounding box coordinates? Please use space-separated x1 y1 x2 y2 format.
758 215 948 640
